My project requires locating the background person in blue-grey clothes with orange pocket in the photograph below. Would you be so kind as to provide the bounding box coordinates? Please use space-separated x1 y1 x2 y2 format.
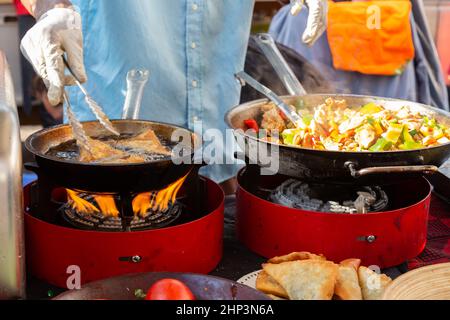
269 0 449 110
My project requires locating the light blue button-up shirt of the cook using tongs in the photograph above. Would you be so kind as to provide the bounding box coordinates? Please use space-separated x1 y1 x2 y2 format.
69 0 254 181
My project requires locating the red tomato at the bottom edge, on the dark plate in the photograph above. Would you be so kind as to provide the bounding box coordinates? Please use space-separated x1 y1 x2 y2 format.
145 279 195 300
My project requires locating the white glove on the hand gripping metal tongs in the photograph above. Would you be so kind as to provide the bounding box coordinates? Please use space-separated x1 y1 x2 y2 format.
21 8 87 105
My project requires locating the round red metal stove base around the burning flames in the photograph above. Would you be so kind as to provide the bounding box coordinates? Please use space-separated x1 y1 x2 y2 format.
24 179 224 288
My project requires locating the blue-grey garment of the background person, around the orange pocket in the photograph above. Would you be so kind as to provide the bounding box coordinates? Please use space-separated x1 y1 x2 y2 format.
269 0 449 110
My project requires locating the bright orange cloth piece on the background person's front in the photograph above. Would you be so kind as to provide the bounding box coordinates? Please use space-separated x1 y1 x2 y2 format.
327 0 415 75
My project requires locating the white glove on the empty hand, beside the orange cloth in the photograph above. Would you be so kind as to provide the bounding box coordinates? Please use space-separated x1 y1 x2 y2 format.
291 0 328 46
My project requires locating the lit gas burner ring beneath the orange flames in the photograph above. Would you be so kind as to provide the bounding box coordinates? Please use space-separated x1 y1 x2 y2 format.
60 193 183 232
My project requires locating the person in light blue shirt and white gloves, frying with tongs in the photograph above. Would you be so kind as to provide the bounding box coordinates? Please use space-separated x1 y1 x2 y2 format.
22 0 327 192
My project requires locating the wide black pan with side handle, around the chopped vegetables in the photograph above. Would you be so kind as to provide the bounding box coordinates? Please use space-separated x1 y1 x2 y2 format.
225 94 450 184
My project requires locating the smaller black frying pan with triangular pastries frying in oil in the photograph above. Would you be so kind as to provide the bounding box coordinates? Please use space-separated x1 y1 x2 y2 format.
25 120 198 192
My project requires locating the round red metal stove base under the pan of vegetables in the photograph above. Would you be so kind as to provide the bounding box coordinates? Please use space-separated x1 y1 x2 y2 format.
236 169 431 268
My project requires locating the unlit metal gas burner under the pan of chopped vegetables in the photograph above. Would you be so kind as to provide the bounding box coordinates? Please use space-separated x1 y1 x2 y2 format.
269 179 389 214
